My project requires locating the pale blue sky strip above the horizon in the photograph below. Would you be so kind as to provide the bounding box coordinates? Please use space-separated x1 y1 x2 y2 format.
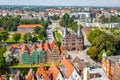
0 0 120 6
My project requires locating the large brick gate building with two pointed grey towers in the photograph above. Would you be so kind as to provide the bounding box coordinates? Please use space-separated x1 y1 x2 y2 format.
61 27 84 51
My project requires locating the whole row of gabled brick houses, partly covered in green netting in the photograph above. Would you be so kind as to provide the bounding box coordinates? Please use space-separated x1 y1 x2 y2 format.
18 41 66 64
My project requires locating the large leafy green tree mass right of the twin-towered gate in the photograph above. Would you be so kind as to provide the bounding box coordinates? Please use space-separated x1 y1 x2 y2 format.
88 34 116 61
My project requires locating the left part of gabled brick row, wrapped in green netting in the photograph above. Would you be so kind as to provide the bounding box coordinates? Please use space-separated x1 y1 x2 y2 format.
19 44 46 64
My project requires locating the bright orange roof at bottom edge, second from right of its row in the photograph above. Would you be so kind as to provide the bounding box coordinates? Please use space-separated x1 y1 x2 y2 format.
49 64 60 80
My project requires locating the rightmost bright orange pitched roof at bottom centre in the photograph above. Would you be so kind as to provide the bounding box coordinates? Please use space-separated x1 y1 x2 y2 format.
62 58 74 78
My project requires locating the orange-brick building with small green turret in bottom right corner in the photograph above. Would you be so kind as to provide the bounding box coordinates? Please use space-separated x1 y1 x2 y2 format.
102 52 120 80
